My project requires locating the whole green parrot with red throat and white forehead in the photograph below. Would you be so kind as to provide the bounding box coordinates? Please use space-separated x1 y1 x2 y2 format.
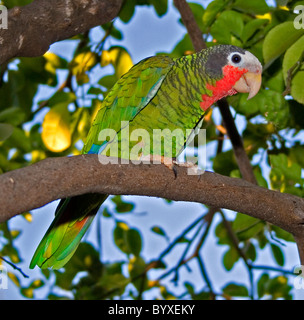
30 45 262 269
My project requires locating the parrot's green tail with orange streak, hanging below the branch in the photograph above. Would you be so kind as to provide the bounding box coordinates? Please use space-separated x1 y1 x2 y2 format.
30 193 108 269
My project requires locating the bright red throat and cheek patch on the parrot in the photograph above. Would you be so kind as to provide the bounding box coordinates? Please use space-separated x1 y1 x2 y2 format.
200 65 248 111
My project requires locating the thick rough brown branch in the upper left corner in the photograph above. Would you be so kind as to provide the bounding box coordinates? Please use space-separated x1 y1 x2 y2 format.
0 0 123 65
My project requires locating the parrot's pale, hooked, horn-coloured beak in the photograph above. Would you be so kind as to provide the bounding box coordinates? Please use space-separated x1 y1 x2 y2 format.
233 72 262 100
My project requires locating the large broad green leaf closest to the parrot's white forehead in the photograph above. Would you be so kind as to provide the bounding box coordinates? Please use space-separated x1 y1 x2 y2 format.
263 21 304 68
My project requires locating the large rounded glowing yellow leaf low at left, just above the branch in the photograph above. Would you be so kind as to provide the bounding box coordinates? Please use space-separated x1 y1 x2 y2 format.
41 104 72 152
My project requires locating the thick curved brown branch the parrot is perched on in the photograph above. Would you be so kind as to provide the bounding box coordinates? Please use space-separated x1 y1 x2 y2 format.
0 155 304 236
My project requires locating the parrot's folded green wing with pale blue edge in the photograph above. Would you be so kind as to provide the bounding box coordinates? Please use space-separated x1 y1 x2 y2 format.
82 56 174 153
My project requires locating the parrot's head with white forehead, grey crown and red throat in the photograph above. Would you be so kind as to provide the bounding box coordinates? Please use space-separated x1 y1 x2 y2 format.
201 45 262 110
